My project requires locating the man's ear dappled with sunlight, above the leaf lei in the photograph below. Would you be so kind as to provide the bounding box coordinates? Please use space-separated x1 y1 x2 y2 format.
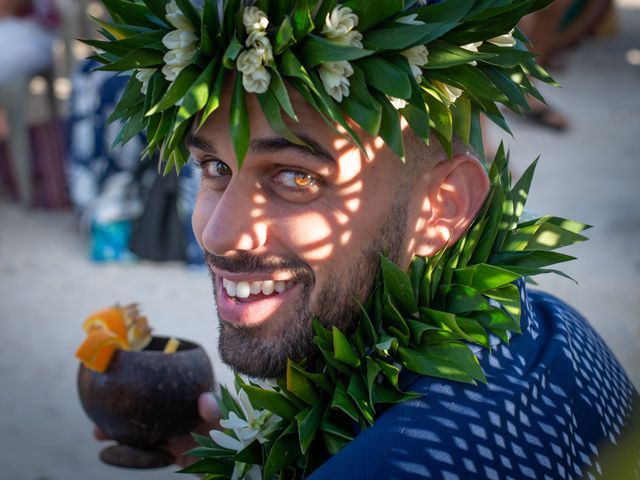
410 154 489 256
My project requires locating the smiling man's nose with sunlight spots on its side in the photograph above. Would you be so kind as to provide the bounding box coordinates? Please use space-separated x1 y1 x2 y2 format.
202 179 267 255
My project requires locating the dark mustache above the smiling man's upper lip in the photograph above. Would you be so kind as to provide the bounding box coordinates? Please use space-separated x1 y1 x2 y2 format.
204 252 314 285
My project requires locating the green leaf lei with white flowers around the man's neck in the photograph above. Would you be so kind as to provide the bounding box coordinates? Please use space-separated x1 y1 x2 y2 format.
182 145 589 479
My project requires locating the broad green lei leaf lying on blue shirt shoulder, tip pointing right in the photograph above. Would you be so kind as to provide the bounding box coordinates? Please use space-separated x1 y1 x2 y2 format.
398 342 487 383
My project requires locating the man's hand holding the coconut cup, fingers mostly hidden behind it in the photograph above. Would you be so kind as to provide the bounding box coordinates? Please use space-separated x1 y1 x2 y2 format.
93 392 222 467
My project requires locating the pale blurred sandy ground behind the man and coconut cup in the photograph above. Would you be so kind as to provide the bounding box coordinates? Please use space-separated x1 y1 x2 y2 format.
0 0 640 480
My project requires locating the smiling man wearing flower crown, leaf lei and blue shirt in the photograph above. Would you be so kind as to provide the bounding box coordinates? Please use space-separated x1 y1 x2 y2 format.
93 0 640 480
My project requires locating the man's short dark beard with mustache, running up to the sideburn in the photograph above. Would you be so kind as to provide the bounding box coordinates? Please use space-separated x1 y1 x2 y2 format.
205 199 407 378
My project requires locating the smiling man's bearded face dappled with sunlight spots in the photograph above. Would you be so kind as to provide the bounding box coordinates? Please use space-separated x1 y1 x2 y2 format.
188 82 420 378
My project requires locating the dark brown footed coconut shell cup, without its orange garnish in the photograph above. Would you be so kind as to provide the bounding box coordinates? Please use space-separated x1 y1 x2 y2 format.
78 337 213 468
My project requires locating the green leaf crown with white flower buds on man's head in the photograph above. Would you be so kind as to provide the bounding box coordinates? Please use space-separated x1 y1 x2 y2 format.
85 0 553 172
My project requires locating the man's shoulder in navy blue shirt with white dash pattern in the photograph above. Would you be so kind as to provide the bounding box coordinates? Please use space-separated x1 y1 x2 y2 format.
314 292 640 480
